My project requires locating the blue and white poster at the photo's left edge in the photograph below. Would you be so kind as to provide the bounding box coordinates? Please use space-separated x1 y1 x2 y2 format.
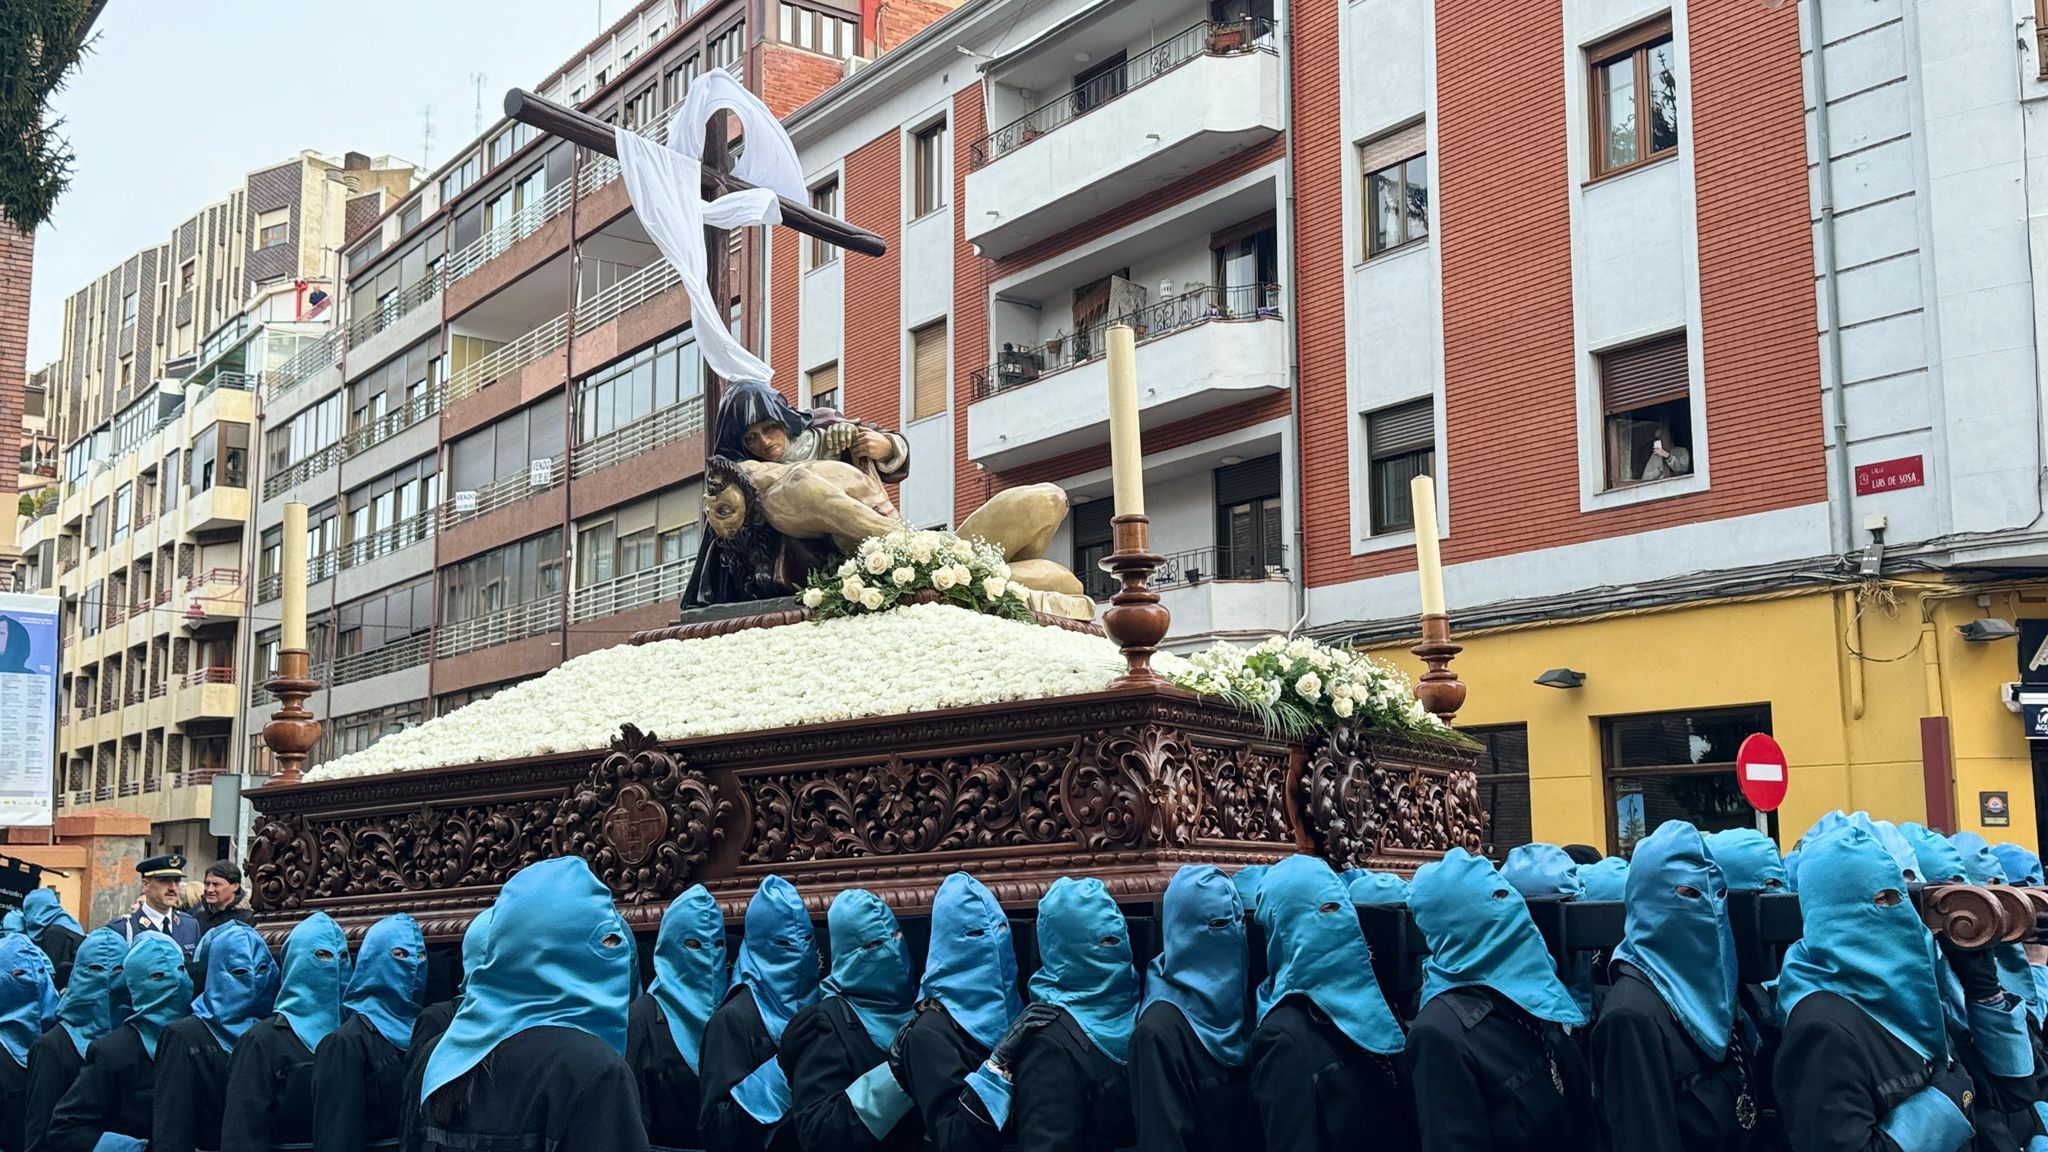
0 592 57 828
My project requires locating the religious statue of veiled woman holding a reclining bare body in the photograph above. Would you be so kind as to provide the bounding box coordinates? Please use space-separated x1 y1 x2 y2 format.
682 381 1094 619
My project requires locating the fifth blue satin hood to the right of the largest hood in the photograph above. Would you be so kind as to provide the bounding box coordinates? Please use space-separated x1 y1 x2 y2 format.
1030 875 1139 1064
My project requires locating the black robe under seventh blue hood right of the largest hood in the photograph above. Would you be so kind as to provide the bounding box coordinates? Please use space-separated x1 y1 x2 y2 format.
1245 996 1415 1152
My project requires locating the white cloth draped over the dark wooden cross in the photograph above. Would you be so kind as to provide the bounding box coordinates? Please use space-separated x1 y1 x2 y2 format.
616 70 805 383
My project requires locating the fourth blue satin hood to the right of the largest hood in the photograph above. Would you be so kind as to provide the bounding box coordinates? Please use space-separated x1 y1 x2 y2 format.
918 871 1024 1047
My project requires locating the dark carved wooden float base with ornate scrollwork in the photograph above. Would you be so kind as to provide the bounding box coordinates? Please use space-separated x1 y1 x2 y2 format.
250 689 1483 941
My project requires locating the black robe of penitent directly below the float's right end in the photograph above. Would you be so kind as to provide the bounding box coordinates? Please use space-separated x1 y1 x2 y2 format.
1407 975 1599 1152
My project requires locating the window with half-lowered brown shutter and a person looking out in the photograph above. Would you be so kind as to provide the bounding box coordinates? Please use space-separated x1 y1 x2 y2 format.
1599 332 1692 488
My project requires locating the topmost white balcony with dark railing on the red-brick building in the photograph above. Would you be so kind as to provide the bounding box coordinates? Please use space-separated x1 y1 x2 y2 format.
965 20 1282 258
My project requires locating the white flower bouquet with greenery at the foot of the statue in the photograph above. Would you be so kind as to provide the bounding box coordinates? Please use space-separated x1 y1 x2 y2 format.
801 529 1032 623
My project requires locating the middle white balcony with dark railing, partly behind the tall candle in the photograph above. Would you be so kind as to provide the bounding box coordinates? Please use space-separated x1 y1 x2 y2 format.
967 285 1286 469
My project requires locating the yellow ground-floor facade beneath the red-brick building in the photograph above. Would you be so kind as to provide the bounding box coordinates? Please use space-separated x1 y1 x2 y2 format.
1374 578 2048 851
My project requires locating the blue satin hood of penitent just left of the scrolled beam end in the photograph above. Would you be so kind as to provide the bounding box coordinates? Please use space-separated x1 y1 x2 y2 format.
1778 826 1948 1060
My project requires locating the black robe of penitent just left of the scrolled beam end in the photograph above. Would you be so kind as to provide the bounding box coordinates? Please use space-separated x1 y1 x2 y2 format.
1774 992 1966 1152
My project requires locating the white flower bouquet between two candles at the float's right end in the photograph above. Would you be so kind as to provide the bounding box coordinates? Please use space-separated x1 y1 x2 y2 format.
1167 635 1454 740
